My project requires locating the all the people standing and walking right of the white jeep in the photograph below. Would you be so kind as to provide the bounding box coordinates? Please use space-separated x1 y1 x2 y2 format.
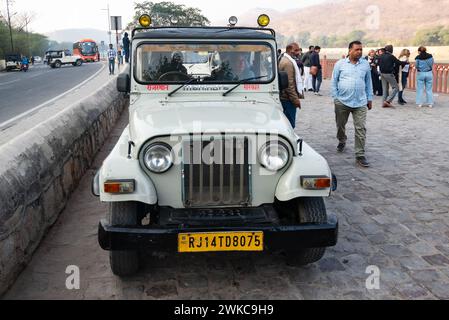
278 41 434 168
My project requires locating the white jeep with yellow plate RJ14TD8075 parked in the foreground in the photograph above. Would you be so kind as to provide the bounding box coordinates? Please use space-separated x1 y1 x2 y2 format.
92 15 338 276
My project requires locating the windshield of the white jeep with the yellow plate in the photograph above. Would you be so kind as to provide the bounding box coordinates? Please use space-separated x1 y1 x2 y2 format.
134 43 275 84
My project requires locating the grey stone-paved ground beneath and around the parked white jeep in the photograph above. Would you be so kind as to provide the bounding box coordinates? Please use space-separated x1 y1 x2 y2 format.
3 82 449 299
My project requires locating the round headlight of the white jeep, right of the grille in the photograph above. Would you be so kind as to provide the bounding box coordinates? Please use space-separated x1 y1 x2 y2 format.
259 141 289 171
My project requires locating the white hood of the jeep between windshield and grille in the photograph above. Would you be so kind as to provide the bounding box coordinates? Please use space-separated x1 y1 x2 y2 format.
129 101 296 149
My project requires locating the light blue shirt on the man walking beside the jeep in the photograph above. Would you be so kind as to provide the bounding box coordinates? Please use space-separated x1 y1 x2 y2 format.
331 58 373 108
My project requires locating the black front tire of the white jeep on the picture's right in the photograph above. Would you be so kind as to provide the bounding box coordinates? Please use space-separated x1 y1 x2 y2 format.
287 197 327 266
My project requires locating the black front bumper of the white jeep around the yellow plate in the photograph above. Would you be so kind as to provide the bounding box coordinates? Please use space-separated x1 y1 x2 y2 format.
98 210 338 252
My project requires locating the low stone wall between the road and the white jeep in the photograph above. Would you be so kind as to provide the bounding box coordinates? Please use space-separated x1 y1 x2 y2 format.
0 80 127 296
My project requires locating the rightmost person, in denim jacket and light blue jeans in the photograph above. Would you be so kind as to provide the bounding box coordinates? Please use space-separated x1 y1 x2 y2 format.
415 46 435 108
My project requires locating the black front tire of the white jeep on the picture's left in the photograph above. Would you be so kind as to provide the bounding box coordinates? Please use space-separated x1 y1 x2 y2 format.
109 202 140 277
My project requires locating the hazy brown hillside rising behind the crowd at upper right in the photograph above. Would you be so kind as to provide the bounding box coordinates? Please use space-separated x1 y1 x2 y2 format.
240 0 449 43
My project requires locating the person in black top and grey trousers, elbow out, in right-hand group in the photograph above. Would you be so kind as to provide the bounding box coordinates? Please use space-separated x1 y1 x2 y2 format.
378 45 405 108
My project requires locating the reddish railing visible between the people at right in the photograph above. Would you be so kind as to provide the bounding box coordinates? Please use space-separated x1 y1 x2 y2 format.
321 59 449 94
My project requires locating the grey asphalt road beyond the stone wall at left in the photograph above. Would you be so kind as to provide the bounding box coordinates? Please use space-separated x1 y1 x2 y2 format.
0 63 103 126
